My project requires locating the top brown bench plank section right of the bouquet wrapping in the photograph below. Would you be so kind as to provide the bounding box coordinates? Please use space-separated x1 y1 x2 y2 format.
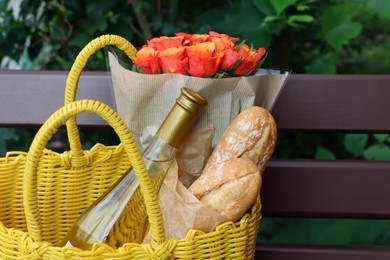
273 75 390 132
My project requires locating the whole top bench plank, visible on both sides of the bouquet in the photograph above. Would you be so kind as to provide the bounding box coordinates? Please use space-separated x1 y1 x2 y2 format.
0 70 390 132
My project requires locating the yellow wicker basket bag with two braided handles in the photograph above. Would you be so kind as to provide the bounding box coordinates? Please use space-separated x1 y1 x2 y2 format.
0 35 261 259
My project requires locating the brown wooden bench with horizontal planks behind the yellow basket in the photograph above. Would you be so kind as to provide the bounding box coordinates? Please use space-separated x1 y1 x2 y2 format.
0 71 390 260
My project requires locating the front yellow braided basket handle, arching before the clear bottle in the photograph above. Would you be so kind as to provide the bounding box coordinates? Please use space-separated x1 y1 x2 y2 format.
23 100 166 244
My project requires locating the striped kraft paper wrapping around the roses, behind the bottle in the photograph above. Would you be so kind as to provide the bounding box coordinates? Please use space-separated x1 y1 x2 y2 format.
107 51 289 150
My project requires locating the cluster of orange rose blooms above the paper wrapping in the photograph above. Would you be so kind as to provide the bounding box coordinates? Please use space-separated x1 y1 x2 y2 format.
133 31 266 78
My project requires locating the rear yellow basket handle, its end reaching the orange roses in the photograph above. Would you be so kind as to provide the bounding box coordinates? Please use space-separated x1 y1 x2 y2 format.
64 34 137 161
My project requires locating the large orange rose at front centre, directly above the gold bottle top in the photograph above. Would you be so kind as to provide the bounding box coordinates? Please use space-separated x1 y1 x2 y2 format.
186 42 222 77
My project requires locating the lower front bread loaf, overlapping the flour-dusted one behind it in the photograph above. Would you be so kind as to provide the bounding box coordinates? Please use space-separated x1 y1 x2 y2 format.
190 158 261 221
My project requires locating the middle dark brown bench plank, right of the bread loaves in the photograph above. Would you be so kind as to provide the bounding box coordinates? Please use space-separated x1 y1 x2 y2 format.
261 160 390 218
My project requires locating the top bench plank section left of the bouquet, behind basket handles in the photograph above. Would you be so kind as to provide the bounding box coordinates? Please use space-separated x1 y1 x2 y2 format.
0 70 114 125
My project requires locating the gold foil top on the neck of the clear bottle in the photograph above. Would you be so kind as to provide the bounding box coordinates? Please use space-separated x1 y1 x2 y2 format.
157 88 207 148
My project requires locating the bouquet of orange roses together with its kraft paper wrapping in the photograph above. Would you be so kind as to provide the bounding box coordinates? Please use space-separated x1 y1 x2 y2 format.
107 31 288 149
